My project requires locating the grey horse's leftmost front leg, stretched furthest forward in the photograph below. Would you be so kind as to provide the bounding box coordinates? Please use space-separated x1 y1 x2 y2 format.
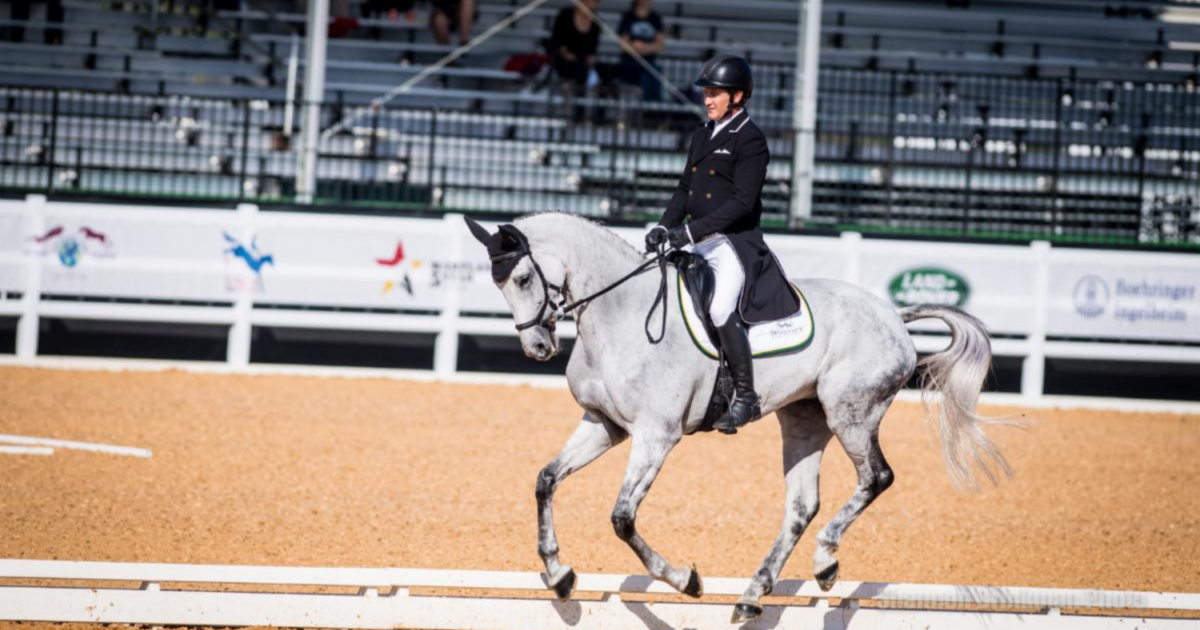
536 412 625 601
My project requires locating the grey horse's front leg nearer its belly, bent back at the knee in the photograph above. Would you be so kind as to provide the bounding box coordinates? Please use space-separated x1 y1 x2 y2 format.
612 432 704 598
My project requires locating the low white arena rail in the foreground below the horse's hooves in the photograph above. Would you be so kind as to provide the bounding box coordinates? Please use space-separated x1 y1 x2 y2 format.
0 559 1200 630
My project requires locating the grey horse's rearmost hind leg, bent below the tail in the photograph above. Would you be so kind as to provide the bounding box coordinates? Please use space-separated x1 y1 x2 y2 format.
812 391 895 590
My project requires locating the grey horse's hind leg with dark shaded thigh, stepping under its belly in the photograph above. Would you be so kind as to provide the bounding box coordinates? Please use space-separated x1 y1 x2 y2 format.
732 400 833 624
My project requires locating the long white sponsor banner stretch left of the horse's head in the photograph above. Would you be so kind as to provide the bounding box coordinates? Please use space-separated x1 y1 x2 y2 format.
10 204 492 312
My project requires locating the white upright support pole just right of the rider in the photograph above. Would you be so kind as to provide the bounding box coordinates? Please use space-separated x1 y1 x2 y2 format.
788 0 821 228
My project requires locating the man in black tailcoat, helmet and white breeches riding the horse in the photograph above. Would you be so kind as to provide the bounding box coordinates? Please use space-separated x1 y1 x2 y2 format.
646 55 800 433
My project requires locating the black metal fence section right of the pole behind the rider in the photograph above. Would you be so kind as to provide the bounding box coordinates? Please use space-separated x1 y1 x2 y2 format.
814 71 1200 246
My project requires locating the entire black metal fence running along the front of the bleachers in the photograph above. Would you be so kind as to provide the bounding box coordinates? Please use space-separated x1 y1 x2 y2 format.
0 66 1200 248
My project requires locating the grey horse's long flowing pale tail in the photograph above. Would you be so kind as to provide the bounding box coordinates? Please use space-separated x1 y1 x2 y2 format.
900 304 1018 490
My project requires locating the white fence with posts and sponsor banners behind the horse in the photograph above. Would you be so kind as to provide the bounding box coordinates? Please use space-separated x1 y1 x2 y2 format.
0 196 1200 396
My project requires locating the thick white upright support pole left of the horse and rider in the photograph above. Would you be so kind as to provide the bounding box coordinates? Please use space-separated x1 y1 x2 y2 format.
296 0 329 203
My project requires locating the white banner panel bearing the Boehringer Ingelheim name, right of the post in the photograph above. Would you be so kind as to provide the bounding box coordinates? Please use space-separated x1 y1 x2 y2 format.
1046 250 1200 342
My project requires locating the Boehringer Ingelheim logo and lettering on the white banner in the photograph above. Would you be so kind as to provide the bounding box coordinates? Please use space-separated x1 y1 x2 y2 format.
1074 275 1196 324
